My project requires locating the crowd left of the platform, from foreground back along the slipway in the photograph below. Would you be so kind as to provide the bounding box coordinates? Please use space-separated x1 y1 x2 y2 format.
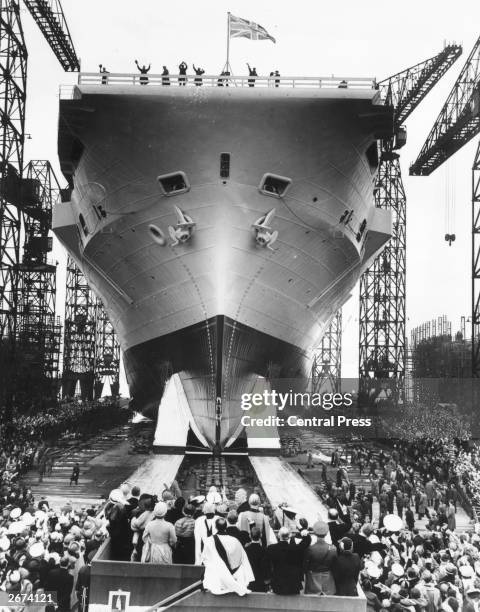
0 401 128 612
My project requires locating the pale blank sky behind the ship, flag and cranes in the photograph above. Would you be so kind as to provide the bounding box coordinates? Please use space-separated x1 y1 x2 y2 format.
21 0 480 392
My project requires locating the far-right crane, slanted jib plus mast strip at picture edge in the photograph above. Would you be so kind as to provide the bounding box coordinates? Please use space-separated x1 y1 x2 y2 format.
410 37 480 378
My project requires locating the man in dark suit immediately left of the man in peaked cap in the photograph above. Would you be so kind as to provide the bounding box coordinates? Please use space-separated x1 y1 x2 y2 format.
265 527 310 595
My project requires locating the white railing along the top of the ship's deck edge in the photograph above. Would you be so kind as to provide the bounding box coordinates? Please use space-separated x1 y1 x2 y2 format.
60 72 378 98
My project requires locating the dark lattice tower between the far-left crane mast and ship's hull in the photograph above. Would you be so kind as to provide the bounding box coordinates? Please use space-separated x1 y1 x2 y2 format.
16 160 61 400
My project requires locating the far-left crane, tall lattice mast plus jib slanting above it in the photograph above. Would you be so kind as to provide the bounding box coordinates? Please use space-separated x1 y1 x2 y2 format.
0 0 80 419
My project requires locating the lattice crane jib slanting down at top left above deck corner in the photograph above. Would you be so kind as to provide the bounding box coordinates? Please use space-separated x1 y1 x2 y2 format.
23 0 80 72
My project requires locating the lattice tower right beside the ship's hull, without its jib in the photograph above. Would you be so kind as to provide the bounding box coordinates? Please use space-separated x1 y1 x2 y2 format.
359 150 406 391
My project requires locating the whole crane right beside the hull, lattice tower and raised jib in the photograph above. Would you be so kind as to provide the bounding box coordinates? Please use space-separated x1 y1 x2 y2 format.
359 44 462 400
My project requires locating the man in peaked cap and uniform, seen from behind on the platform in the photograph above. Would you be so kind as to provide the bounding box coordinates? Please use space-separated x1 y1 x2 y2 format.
303 521 337 595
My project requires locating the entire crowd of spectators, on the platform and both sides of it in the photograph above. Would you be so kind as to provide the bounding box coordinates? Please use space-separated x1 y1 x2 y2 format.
0 402 480 612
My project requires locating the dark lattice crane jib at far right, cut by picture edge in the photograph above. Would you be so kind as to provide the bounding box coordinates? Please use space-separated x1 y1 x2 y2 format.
410 37 480 176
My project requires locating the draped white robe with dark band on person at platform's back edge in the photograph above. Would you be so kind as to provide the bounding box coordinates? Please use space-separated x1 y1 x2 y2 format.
202 535 255 595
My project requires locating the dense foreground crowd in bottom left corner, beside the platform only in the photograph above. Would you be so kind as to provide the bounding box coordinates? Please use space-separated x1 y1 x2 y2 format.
0 484 108 612
